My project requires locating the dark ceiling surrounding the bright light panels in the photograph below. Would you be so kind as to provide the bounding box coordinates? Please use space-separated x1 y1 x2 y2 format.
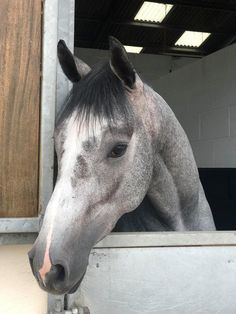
75 0 236 57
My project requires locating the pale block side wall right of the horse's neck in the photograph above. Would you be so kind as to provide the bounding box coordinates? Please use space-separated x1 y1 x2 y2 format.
153 45 236 167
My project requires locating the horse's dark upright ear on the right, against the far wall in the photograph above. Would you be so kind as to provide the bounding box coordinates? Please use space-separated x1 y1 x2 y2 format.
109 36 135 88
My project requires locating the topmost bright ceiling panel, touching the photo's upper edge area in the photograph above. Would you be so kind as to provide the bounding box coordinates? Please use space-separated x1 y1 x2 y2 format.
134 1 173 23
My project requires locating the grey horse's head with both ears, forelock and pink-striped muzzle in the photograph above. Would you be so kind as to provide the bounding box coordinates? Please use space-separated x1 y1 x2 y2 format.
29 37 155 294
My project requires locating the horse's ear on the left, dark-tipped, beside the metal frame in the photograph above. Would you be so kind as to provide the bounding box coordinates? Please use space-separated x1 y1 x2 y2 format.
57 40 91 83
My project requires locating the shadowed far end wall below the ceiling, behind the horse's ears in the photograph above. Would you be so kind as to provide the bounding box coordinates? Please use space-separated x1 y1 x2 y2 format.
75 48 195 84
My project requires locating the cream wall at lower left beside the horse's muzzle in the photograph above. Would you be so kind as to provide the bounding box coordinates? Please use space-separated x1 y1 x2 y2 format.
0 245 47 314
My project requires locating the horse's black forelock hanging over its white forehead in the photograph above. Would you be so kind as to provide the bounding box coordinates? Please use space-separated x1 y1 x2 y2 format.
56 62 132 125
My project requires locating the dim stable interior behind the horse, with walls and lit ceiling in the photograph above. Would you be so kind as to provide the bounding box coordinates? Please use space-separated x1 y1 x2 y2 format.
74 0 236 230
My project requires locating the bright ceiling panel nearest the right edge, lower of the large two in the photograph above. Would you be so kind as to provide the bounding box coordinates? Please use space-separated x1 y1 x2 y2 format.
175 31 210 47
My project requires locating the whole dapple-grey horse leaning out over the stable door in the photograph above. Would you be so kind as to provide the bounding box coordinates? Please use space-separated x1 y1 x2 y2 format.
29 37 215 294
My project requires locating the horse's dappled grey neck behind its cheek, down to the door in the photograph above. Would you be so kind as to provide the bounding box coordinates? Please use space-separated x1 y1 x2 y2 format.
115 87 215 231
